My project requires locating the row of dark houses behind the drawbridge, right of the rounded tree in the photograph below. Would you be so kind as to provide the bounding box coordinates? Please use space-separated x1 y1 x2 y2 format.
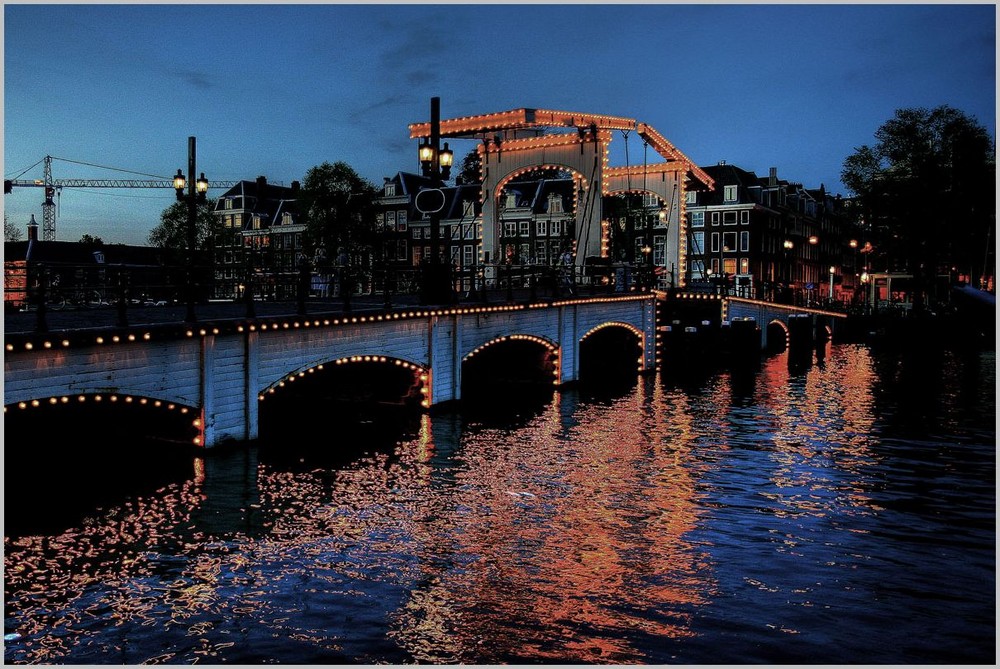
368 163 870 301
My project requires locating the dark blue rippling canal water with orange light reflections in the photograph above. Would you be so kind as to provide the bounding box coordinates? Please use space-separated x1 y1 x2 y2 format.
4 344 996 664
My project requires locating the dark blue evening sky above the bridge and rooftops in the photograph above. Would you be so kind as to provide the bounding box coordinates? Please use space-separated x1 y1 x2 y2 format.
3 4 996 244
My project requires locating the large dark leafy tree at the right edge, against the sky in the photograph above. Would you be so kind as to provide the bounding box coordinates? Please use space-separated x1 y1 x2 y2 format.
841 105 996 310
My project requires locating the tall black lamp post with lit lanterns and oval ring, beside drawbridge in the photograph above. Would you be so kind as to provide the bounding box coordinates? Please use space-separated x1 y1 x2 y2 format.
416 97 455 304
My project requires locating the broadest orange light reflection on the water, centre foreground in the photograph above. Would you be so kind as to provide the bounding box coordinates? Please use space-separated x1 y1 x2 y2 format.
392 381 706 663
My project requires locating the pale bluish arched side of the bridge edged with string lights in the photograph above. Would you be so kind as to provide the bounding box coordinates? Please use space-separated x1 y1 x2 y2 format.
4 293 656 447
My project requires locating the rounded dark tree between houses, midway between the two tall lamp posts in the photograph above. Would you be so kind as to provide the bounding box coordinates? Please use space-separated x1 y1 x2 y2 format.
297 161 378 257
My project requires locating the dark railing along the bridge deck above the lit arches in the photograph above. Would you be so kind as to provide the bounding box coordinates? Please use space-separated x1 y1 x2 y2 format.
4 261 655 332
